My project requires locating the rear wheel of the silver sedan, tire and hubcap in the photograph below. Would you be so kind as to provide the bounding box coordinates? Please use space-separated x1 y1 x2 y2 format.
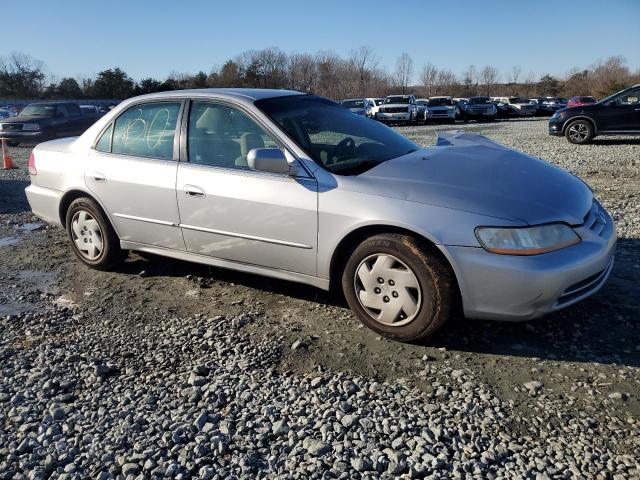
66 197 126 270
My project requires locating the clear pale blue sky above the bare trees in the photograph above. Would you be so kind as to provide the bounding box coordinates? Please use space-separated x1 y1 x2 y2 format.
5 0 640 81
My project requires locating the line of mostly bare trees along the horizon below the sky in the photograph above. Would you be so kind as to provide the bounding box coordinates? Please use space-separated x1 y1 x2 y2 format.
0 46 640 100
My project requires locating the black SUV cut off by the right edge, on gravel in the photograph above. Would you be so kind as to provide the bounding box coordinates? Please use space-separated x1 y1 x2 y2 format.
549 84 640 144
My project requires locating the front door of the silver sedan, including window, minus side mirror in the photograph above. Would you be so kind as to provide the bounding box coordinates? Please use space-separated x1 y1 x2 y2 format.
176 101 318 275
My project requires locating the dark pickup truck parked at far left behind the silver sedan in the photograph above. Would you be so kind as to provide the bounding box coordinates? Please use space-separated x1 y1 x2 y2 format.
0 102 98 146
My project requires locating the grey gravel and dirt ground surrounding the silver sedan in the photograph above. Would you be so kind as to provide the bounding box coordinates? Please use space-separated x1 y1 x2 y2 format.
0 120 640 480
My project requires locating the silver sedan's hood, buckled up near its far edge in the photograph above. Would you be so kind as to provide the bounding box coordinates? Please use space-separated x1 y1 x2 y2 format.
341 132 593 225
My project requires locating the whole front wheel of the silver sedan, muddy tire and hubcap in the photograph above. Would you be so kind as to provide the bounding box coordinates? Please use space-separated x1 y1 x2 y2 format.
342 234 457 342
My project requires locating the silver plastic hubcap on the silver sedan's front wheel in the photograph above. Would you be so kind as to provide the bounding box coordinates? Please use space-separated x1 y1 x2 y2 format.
354 254 422 327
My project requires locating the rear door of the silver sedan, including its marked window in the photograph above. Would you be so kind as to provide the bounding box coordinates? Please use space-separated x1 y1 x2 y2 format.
85 100 185 250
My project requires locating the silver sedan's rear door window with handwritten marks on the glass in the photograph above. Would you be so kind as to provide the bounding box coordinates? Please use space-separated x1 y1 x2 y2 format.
111 102 180 160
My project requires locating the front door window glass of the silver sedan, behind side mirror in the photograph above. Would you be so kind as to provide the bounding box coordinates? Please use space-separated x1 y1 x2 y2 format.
188 102 278 169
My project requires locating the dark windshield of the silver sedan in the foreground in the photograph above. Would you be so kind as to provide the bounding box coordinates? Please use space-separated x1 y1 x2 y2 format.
255 95 420 175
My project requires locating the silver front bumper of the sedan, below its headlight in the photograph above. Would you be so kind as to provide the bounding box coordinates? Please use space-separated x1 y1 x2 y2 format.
442 214 616 321
